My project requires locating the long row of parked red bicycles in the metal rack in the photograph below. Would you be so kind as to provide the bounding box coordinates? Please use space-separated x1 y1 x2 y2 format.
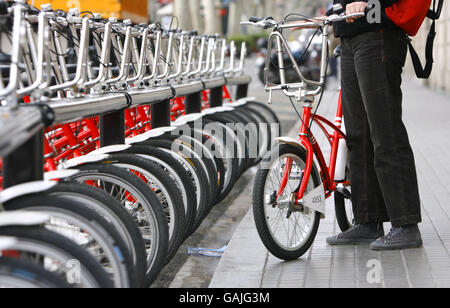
0 0 280 288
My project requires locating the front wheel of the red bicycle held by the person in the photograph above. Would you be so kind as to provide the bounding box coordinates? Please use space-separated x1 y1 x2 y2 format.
253 144 321 261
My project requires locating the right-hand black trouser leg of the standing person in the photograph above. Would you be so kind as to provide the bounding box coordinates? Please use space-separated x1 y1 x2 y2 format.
352 30 421 228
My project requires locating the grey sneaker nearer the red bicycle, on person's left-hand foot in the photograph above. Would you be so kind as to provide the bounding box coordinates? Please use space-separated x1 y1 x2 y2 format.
327 224 384 246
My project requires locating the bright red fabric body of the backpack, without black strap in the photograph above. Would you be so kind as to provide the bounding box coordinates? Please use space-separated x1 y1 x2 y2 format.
386 0 431 36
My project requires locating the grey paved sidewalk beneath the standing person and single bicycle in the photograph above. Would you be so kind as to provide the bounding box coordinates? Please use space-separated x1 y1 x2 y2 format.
210 81 450 288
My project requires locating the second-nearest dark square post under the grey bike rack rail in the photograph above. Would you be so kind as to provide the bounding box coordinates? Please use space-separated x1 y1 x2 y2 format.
99 110 125 147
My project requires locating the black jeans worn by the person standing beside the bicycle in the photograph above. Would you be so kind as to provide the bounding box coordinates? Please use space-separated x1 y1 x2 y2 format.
341 29 421 227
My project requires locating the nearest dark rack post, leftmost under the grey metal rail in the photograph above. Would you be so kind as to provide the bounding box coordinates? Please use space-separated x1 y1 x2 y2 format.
3 129 44 189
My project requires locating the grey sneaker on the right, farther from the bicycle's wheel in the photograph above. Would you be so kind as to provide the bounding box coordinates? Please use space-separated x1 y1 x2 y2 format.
370 225 423 251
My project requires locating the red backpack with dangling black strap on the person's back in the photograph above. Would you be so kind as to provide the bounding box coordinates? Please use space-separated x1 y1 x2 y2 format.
385 0 444 79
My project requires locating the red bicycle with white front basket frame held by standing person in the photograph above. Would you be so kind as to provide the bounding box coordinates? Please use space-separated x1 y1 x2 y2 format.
243 14 360 260
